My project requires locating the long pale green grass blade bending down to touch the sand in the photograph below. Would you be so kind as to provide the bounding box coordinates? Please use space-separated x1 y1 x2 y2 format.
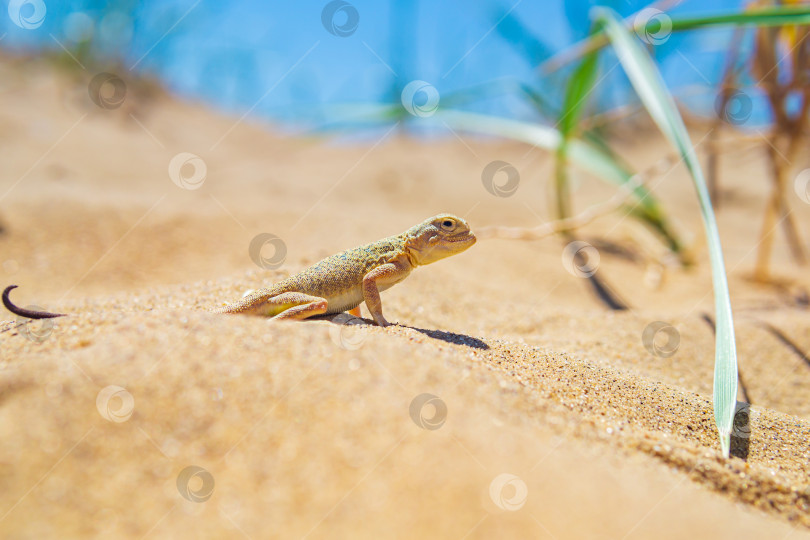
595 8 737 457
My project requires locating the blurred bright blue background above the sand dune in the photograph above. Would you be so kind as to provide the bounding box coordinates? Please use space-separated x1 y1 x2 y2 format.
0 0 767 124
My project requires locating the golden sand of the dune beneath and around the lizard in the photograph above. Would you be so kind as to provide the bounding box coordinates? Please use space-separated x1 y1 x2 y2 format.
0 59 810 539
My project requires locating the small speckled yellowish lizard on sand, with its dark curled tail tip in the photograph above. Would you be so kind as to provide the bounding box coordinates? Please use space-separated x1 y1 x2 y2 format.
2 214 476 327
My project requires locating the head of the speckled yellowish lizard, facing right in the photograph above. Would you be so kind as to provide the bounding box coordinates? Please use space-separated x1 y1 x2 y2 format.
405 214 475 265
